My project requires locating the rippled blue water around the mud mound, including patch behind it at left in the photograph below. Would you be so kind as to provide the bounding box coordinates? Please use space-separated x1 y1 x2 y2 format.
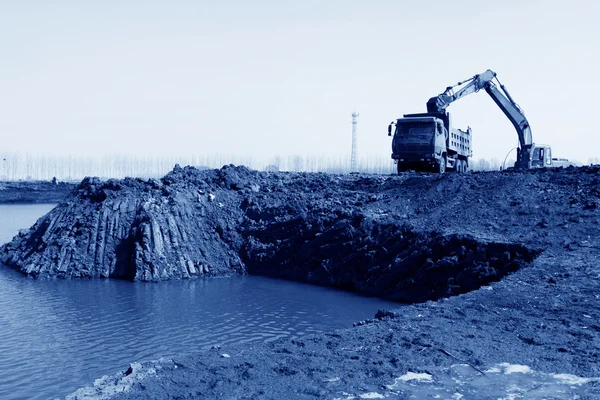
0 205 397 399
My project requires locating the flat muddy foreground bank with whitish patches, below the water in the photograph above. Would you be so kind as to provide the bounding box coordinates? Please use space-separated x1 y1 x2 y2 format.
66 250 600 400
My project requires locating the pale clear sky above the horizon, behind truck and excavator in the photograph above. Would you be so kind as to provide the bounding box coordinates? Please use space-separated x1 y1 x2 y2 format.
0 0 600 161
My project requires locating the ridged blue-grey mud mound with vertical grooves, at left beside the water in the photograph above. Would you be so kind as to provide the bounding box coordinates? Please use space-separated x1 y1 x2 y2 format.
1 168 251 281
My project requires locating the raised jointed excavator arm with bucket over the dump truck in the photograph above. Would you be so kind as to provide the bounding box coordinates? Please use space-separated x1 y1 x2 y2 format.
427 69 533 169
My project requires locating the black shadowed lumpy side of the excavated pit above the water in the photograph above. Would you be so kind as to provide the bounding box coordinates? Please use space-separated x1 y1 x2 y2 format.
241 215 539 303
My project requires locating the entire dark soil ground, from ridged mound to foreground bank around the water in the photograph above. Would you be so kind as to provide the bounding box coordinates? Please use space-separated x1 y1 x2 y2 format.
0 166 600 399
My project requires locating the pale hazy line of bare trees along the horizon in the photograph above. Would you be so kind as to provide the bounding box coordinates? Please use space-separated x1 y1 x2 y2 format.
0 153 600 181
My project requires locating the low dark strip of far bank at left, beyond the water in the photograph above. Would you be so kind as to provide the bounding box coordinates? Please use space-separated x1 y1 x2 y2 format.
0 181 75 204
